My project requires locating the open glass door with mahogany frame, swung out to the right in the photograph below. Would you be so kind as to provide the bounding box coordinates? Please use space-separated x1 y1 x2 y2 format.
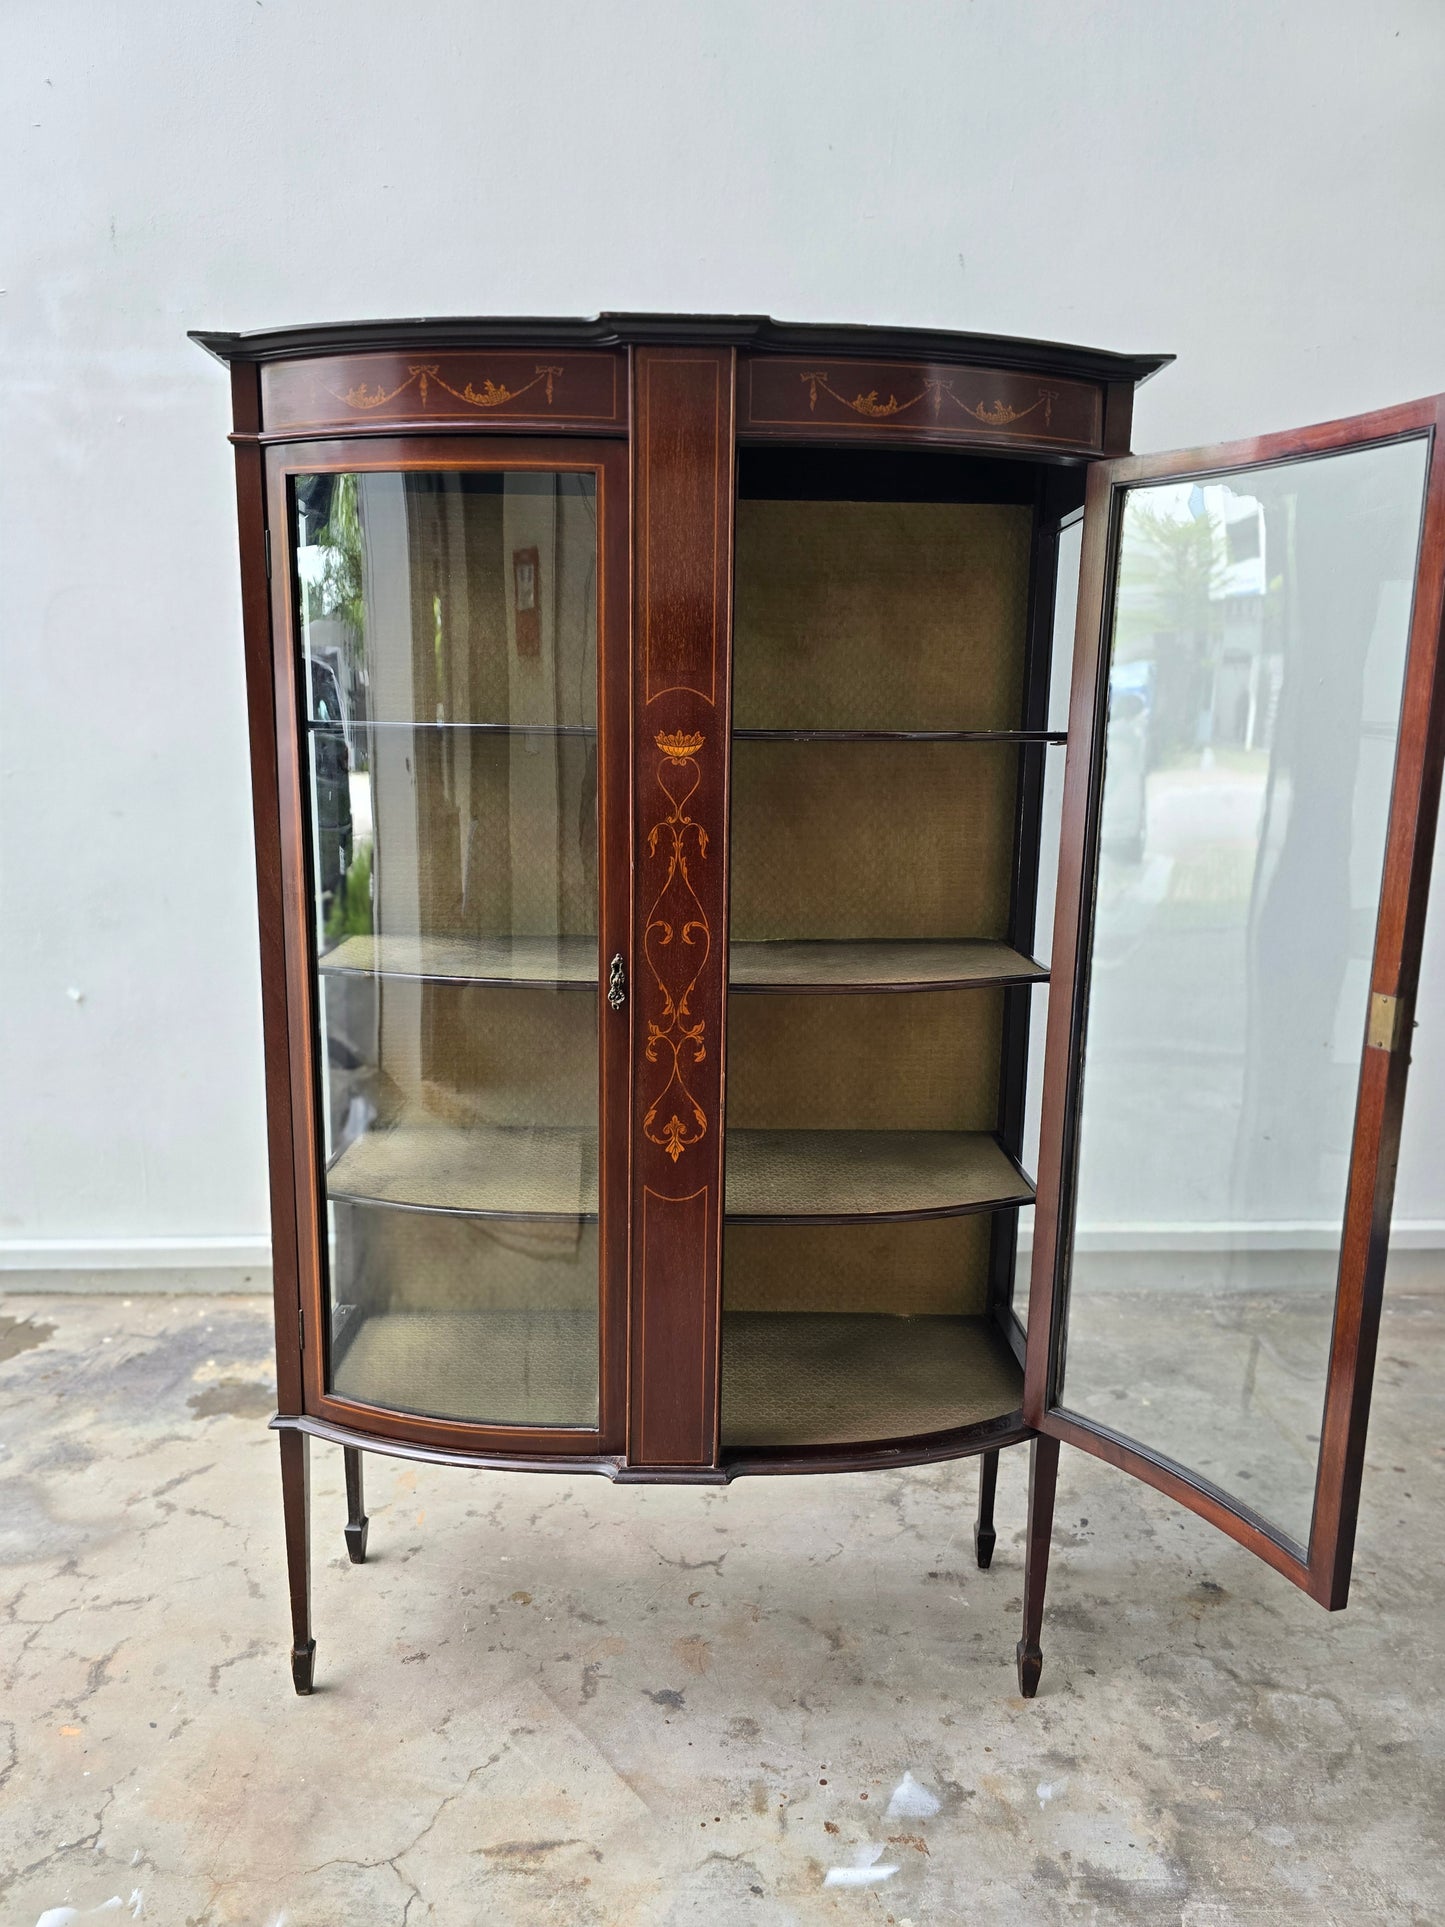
1025 387 1445 1607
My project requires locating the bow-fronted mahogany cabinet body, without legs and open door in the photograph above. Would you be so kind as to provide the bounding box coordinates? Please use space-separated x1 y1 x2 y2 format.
222 322 1137 1480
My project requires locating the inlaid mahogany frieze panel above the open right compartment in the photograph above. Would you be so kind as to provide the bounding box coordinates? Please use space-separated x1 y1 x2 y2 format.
738 355 1127 455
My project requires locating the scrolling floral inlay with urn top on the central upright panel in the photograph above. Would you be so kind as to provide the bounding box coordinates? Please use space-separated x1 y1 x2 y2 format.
642 730 713 1164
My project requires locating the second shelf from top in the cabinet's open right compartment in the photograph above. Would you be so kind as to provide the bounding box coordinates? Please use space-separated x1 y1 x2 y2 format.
728 940 1048 990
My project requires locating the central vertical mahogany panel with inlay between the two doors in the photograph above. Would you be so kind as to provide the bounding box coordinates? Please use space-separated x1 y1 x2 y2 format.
628 347 736 1466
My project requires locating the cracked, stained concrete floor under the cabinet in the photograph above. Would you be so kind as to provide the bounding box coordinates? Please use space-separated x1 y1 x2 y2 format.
0 1293 1445 1927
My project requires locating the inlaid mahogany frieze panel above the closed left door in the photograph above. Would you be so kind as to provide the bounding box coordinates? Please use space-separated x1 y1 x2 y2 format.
258 349 626 436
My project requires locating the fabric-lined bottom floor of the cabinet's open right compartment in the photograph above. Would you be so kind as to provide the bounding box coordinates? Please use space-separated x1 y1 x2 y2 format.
719 1310 1023 1449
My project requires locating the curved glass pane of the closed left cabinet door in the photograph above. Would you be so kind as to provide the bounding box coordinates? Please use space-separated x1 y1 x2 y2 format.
293 466 599 1430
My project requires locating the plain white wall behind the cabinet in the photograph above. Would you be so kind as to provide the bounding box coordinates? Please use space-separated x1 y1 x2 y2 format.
0 0 1445 1266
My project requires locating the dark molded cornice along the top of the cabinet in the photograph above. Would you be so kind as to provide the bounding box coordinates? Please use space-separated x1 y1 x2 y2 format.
189 314 1173 382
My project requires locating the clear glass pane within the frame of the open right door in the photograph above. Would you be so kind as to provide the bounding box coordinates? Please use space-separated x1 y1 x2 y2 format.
1064 441 1426 1545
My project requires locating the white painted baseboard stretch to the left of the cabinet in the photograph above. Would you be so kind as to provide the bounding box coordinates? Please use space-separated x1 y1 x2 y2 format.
0 1237 272 1297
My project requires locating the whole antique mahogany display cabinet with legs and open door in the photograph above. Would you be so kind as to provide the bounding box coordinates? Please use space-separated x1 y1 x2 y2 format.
197 316 1445 1694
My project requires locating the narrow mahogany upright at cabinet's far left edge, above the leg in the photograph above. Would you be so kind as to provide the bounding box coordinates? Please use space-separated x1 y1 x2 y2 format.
231 362 302 1412
